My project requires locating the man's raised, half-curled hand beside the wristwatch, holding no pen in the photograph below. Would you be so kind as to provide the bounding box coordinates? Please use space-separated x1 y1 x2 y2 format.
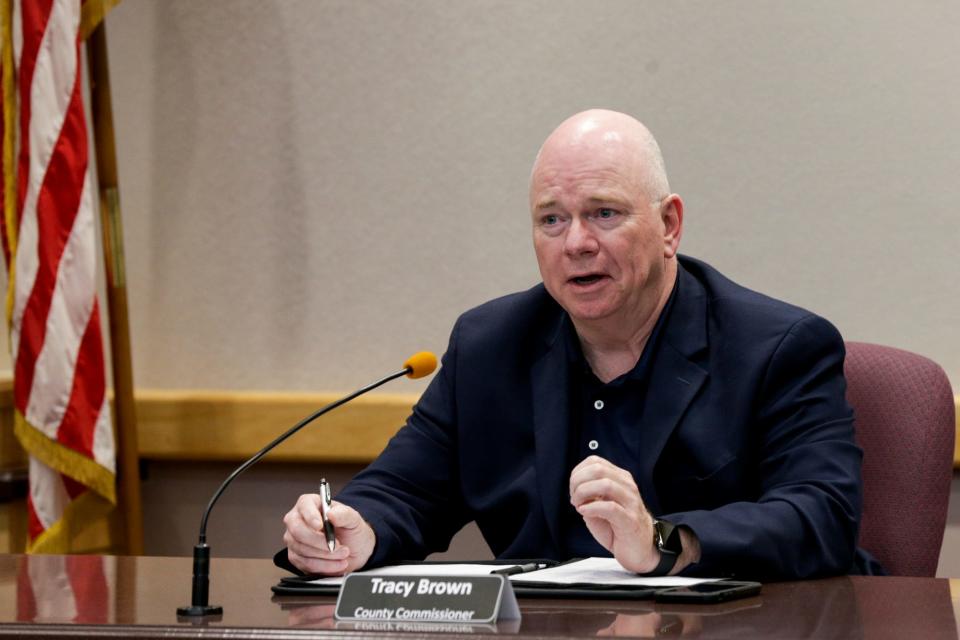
570 456 660 573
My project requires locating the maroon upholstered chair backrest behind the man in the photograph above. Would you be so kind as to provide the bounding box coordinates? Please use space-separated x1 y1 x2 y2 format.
844 342 956 576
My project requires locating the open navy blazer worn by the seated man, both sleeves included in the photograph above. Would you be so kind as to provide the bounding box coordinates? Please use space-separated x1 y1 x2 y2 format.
337 257 862 579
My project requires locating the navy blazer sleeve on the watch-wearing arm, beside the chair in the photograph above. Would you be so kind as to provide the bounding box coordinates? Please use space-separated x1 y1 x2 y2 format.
661 315 862 579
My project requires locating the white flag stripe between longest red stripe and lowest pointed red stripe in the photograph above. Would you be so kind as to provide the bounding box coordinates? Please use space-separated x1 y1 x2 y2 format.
25 172 96 440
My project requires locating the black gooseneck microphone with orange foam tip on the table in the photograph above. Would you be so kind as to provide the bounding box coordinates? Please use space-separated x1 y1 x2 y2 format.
177 351 437 617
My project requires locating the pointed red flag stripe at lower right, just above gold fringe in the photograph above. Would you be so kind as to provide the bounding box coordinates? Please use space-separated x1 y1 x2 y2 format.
57 301 106 458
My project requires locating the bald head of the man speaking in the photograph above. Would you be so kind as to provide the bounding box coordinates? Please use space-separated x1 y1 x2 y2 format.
530 109 683 333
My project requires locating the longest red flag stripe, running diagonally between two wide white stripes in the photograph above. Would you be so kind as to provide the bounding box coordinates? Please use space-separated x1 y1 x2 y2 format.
13 57 87 415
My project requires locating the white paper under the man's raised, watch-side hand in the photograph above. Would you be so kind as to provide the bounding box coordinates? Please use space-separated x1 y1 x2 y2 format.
510 558 719 587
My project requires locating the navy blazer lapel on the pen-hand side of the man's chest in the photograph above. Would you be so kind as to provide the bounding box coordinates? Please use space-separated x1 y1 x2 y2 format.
531 317 570 549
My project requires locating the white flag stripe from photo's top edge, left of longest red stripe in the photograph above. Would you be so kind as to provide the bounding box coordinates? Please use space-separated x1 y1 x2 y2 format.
10 0 80 366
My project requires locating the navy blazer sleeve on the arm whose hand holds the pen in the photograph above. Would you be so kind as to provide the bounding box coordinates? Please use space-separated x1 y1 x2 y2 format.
337 321 469 567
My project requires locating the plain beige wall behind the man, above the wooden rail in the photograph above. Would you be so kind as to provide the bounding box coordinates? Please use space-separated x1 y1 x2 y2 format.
67 0 960 391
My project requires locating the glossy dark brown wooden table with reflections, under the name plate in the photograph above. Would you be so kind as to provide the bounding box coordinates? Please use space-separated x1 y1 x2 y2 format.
0 555 957 640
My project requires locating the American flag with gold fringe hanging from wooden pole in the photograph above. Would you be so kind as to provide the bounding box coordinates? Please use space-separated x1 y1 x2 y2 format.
2 0 116 553
